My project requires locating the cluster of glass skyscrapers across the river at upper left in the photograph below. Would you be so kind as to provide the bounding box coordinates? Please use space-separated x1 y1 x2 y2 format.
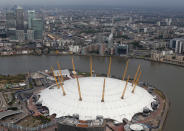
1 6 44 42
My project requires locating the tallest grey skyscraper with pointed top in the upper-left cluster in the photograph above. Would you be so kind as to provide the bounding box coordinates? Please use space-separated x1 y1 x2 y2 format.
16 7 24 30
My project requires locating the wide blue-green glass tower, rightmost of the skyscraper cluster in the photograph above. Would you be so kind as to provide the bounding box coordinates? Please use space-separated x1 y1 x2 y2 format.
32 19 43 40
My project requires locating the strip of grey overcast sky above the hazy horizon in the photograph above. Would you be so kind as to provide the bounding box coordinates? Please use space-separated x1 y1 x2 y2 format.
0 0 184 7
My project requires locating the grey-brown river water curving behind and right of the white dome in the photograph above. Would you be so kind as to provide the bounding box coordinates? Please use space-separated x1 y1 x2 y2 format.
0 56 184 131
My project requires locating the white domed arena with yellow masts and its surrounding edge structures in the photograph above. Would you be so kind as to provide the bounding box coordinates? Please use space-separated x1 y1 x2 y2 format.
28 57 168 131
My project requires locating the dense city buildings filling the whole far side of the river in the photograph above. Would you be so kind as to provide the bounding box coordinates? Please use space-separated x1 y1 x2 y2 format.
0 7 184 66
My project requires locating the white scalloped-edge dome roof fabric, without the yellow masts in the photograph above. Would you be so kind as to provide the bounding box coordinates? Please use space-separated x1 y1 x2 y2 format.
39 77 154 122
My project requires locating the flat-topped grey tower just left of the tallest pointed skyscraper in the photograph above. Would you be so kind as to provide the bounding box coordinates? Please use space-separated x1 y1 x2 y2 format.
6 11 16 28
